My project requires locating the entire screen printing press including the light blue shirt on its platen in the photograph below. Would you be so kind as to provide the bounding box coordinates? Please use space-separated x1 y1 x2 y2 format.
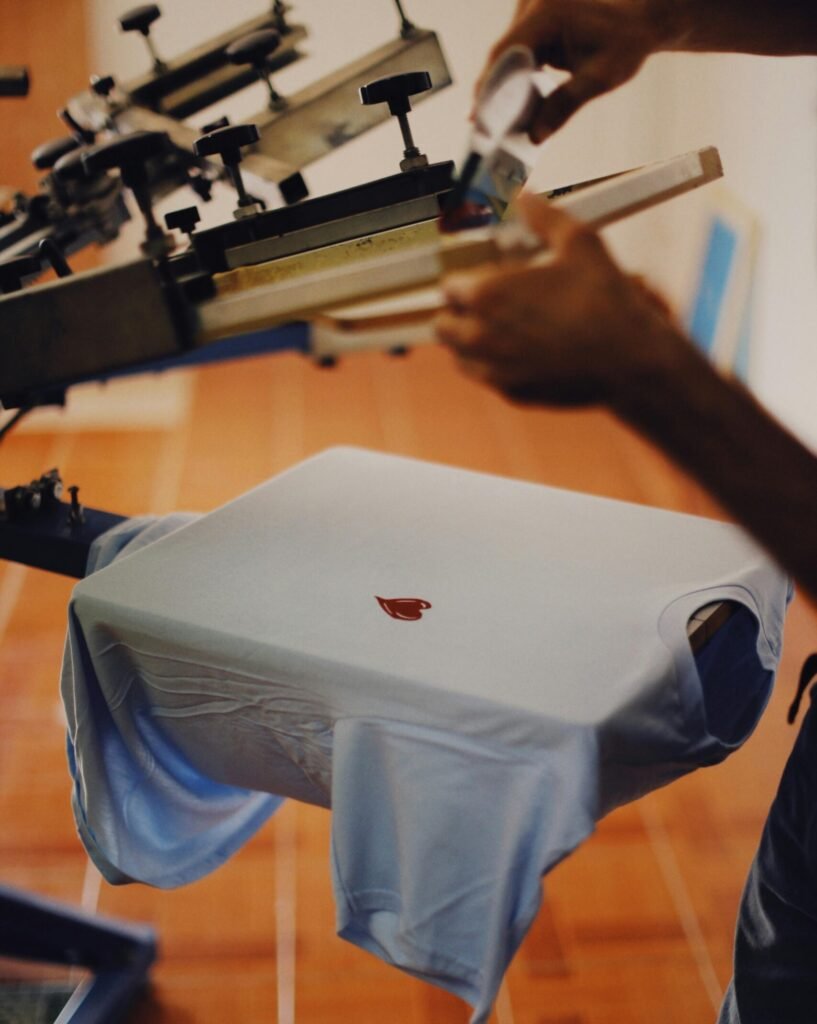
0 0 761 1024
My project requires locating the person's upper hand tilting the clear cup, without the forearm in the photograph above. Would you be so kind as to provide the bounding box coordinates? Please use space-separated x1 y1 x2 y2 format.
476 0 665 142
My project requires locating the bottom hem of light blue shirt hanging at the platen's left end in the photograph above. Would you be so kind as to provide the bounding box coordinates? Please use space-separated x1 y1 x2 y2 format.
61 513 282 888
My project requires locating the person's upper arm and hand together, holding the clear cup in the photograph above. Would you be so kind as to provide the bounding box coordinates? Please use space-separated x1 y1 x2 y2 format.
477 0 817 142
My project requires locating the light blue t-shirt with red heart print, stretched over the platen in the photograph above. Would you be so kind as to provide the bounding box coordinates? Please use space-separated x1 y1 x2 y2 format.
62 449 789 1022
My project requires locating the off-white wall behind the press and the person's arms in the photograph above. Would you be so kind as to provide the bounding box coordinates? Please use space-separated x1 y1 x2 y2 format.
87 0 817 445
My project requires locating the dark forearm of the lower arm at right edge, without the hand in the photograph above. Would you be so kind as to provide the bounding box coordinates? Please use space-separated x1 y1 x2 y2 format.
613 331 817 598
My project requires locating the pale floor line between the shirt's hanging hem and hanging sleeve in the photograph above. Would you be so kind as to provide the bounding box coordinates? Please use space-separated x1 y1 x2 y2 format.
274 801 298 1024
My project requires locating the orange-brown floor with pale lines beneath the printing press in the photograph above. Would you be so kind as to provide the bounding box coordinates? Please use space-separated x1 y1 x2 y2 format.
0 350 817 1024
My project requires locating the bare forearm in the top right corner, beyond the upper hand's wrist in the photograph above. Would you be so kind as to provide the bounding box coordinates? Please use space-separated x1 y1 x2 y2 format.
659 0 817 56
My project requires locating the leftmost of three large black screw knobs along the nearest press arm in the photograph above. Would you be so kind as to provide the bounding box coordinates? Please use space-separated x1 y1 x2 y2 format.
82 131 170 256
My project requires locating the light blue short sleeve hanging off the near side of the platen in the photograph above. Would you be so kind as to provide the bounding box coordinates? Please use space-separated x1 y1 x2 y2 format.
332 719 598 1024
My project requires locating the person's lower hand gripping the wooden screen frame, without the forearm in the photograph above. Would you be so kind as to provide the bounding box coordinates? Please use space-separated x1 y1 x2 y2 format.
434 195 688 407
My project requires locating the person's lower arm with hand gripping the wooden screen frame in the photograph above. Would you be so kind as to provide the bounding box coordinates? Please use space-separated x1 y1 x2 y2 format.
435 197 817 598
